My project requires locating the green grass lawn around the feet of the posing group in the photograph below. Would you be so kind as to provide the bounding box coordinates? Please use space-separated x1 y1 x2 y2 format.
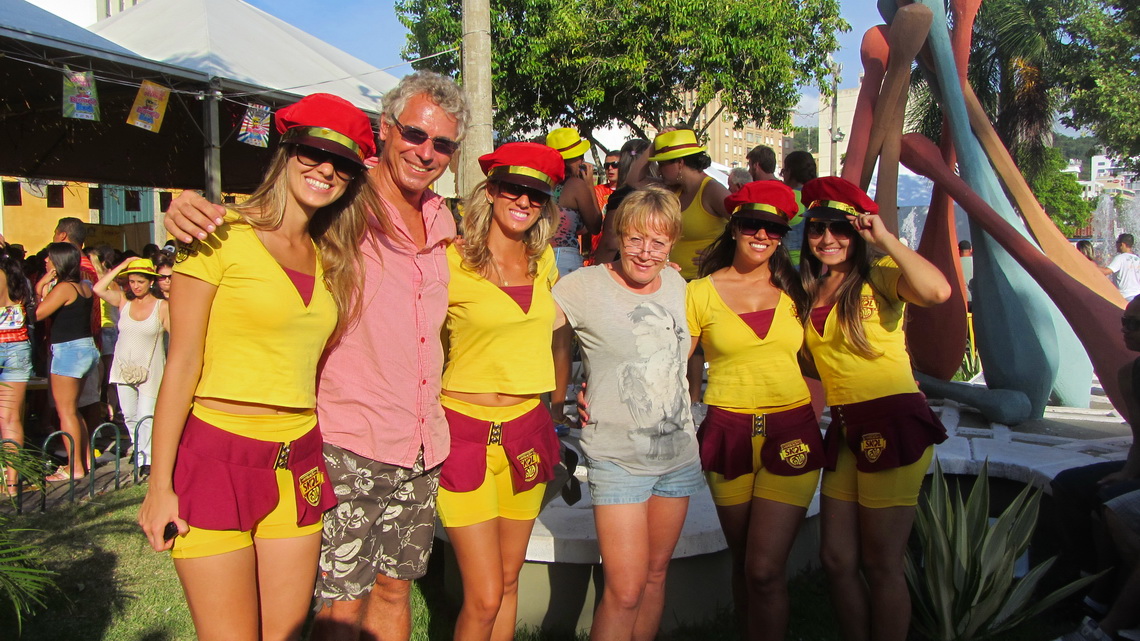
0 486 1080 641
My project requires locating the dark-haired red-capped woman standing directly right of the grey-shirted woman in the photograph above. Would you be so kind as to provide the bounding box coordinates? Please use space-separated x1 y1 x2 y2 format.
686 180 823 639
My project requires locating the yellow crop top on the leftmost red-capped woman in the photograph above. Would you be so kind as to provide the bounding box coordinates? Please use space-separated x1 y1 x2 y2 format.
174 214 336 407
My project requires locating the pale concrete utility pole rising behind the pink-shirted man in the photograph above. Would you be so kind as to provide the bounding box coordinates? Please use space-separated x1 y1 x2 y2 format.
458 0 492 196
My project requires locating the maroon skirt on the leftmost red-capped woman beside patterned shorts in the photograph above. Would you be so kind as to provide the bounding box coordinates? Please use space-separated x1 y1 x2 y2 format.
173 414 336 532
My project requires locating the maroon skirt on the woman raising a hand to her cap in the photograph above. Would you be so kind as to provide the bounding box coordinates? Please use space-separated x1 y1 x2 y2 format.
824 391 946 472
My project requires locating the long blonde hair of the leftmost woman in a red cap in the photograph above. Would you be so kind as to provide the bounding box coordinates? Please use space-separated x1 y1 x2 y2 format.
231 145 392 335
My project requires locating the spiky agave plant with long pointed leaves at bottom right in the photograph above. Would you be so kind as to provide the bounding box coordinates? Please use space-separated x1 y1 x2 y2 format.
906 461 1097 641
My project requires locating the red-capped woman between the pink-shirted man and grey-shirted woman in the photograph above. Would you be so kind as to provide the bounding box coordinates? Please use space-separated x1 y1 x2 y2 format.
438 143 563 640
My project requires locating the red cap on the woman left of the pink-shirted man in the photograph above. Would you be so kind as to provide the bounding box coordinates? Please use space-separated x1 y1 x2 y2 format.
277 94 376 167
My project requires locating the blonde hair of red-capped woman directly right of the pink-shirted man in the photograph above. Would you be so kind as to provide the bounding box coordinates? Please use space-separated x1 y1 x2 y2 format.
459 180 559 278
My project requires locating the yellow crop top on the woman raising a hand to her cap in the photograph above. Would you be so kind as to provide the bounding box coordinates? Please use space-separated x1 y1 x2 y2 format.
805 257 919 405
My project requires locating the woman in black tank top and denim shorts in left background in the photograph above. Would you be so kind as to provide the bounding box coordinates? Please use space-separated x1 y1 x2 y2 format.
35 243 99 481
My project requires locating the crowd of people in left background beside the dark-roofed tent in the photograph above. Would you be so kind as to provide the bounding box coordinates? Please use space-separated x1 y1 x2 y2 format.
0 218 174 488
